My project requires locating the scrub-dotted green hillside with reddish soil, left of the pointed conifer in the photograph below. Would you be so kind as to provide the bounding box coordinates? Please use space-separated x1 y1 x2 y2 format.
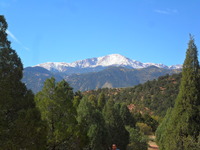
84 73 181 117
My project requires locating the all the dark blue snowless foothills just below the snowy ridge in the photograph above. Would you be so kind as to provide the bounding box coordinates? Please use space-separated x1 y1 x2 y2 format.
22 66 180 93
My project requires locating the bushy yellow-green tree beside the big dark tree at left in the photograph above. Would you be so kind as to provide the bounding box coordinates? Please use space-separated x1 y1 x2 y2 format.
35 78 79 150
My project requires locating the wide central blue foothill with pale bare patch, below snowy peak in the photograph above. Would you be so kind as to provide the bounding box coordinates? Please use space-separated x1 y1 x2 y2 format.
65 66 180 91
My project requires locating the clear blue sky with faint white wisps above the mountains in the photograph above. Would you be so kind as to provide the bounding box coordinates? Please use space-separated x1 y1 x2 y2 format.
0 0 200 67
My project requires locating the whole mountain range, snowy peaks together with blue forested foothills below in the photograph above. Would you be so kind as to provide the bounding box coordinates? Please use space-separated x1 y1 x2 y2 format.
22 54 182 93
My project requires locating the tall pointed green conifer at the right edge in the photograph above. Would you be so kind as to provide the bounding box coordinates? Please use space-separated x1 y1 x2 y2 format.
160 36 200 150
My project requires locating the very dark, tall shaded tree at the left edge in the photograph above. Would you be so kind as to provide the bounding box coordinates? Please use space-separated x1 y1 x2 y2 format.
0 15 46 149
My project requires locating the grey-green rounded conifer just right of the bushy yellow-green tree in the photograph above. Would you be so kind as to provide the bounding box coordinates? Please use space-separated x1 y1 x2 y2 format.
77 97 108 150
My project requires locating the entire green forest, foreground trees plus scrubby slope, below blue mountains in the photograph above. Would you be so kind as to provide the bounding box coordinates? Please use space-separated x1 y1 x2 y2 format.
0 15 200 150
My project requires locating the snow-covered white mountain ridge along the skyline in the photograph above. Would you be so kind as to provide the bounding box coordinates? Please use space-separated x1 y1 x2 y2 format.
36 54 182 72
